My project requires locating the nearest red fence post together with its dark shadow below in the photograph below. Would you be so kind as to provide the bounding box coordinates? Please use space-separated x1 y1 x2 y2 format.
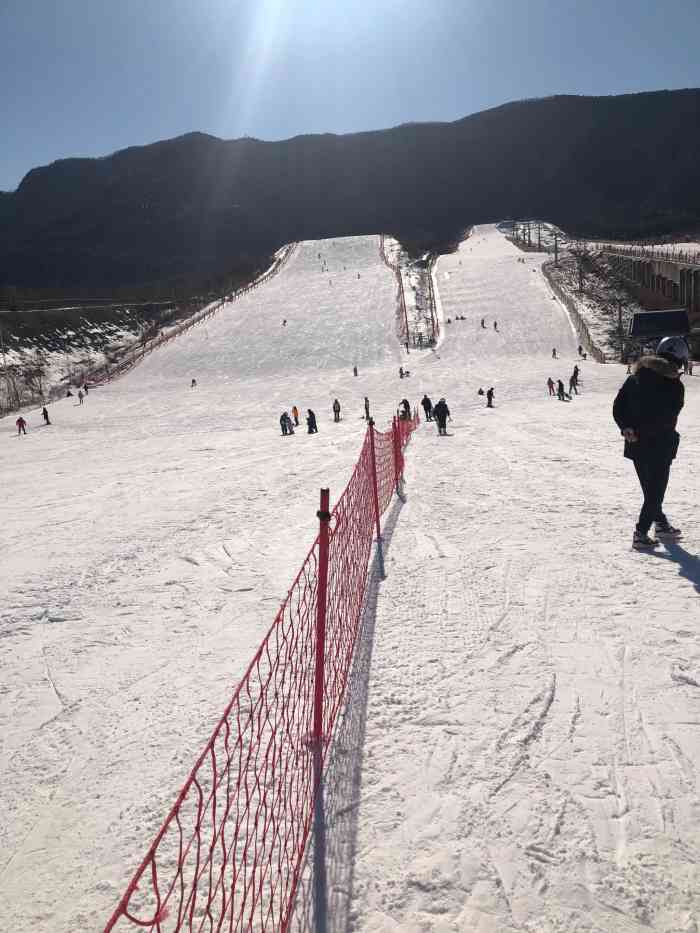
313 489 331 933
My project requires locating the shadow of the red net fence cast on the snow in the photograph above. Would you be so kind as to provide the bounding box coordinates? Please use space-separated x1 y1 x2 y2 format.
290 496 406 933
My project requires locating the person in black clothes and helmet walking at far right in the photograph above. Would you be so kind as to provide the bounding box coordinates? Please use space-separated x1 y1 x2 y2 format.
613 337 688 551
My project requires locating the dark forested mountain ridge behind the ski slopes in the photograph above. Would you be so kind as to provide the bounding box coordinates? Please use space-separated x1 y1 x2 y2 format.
0 90 700 289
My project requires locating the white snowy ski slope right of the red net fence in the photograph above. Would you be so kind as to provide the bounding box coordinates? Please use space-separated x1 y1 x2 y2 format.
350 228 700 933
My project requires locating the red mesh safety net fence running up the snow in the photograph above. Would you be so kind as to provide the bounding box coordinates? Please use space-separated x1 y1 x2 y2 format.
105 414 418 933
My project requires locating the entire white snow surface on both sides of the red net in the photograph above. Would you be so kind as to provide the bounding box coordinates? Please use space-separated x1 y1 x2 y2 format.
0 227 700 933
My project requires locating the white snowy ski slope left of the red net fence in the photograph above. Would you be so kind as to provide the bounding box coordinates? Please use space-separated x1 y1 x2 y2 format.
0 237 403 933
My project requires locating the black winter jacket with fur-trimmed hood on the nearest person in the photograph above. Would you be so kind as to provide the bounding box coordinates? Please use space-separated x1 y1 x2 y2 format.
613 356 685 461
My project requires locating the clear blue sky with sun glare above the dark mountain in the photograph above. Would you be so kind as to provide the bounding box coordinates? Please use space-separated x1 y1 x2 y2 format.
0 0 700 190
